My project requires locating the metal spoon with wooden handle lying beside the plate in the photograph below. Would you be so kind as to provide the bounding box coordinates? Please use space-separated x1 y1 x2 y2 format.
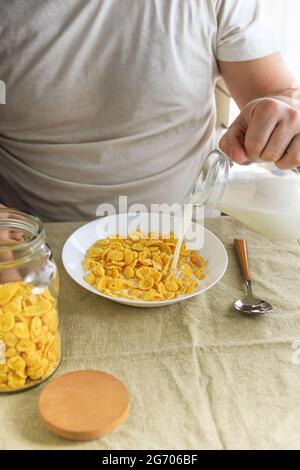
234 240 273 315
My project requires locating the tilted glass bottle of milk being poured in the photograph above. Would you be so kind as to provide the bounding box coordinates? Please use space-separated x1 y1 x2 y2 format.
192 150 300 240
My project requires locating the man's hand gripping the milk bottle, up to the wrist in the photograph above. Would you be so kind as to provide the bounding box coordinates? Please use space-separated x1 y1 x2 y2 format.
220 98 300 169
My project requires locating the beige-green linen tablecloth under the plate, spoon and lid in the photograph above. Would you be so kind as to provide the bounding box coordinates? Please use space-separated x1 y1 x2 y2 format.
0 217 300 450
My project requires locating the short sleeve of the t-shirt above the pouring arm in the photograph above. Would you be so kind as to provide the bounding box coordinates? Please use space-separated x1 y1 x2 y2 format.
216 0 278 62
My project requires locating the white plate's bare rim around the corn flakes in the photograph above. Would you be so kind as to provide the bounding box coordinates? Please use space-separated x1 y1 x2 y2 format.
62 213 228 307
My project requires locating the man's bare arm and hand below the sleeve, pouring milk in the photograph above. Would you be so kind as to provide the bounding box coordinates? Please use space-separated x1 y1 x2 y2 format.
219 53 300 169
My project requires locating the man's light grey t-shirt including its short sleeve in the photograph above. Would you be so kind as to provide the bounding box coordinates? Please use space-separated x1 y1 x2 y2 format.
0 0 275 220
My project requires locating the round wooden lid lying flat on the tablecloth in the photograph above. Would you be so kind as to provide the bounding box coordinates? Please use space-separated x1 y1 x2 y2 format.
39 370 129 441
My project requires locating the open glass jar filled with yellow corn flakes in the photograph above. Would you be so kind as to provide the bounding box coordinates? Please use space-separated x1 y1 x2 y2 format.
0 208 61 393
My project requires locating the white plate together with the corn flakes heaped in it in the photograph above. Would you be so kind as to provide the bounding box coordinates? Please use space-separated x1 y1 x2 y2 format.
62 213 228 307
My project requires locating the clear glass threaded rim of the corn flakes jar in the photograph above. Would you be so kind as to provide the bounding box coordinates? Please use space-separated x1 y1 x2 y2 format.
0 207 45 264
